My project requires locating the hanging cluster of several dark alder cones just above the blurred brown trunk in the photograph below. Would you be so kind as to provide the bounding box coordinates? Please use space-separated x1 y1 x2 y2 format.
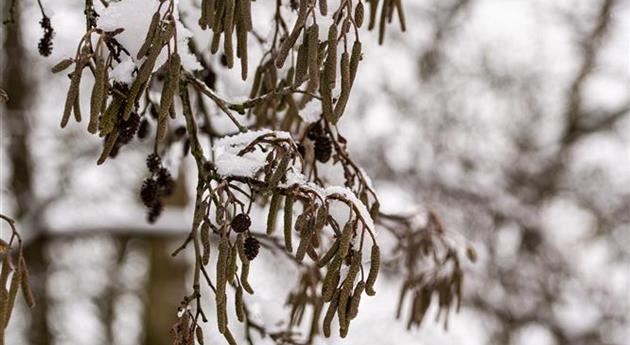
140 153 175 223
